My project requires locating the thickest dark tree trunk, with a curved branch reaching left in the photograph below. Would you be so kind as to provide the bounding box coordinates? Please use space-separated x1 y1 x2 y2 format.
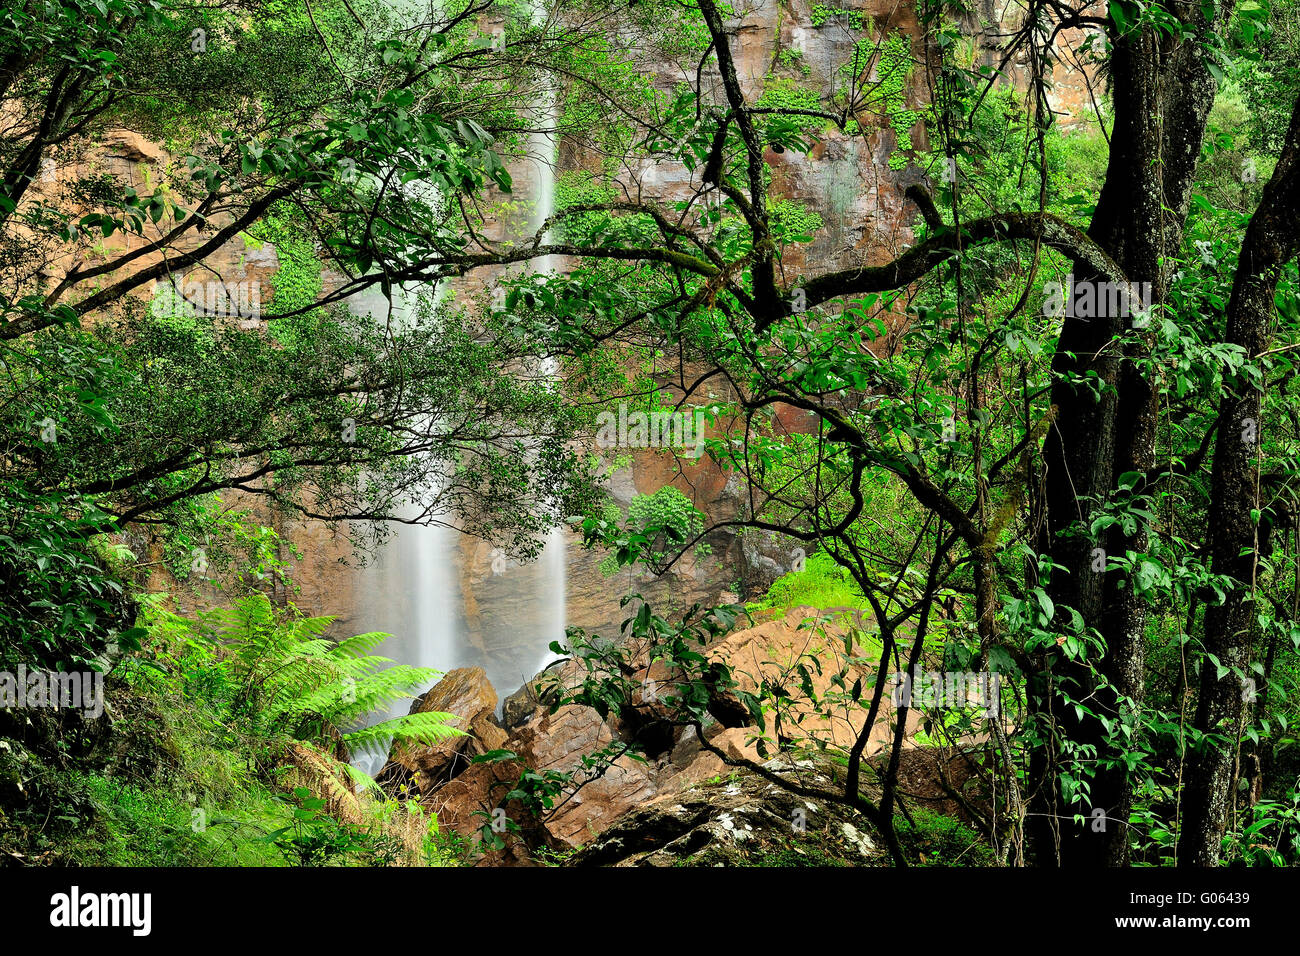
1030 13 1214 866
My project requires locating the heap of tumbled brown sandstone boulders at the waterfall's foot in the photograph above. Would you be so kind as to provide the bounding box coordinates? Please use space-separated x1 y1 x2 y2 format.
423 609 946 865
